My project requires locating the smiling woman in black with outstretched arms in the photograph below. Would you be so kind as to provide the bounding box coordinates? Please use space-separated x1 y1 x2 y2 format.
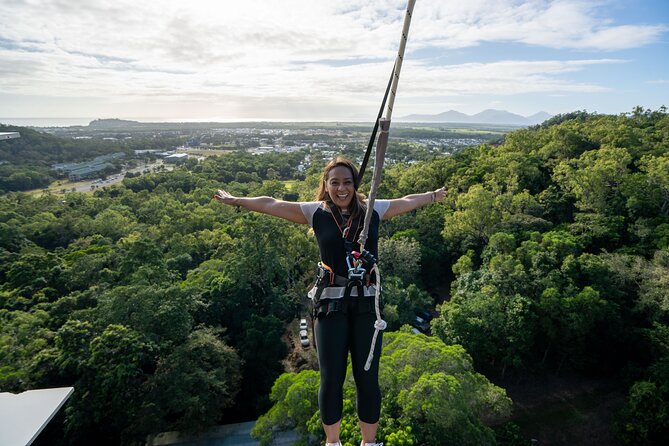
214 157 446 446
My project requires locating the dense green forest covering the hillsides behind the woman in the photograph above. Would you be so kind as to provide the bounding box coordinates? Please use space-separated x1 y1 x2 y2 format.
0 108 669 446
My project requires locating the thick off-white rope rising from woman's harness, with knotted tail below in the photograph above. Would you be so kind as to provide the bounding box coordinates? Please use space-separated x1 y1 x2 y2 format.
358 0 416 371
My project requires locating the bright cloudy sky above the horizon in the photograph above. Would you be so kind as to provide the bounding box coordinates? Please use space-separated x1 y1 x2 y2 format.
0 0 669 122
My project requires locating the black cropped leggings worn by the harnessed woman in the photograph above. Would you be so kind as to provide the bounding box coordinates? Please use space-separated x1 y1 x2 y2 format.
315 298 383 425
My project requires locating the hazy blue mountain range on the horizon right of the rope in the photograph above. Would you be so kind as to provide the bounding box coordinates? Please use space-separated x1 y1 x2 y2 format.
397 109 552 126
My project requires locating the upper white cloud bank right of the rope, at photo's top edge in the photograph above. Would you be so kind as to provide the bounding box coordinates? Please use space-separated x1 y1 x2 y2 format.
413 0 669 51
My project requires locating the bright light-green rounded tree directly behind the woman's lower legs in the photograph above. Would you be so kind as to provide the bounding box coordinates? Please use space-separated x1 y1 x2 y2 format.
253 327 511 445
